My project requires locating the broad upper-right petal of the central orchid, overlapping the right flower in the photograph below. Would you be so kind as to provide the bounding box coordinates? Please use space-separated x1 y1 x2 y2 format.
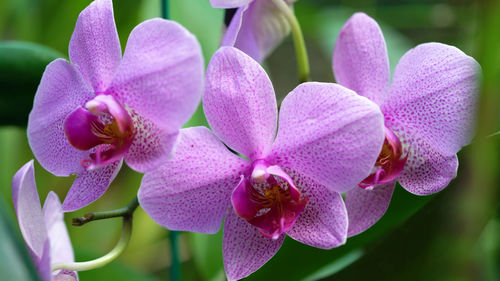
273 82 385 192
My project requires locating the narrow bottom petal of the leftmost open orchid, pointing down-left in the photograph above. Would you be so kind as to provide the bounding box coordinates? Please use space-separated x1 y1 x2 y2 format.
62 160 123 212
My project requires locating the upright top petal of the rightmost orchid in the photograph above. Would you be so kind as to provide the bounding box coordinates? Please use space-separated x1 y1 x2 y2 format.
333 13 391 105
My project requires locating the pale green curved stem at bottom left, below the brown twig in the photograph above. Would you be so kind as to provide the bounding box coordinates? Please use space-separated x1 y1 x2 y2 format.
52 215 132 271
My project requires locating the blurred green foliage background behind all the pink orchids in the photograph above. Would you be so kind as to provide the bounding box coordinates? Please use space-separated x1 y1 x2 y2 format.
0 0 500 281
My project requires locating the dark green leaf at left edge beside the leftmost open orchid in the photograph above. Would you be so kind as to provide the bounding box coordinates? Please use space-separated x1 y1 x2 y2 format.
0 41 64 126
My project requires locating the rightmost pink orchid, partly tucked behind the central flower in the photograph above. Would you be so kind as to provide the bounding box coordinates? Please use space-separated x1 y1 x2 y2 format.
333 13 480 236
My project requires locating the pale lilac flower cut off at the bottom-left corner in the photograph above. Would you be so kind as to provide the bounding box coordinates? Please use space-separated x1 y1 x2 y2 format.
12 160 78 281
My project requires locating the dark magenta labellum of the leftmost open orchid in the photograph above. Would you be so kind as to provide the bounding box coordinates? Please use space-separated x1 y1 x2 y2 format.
64 95 134 169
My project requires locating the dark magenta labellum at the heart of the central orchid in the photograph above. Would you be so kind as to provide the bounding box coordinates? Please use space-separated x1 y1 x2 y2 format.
231 161 309 239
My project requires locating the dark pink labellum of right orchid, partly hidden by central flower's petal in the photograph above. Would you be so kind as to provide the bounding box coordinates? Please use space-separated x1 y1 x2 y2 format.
358 128 408 189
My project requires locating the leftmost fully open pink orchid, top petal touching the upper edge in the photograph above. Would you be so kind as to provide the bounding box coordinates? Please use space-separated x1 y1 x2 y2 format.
28 0 203 211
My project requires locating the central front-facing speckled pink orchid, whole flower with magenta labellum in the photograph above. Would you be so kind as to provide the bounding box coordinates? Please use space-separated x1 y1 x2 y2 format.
139 47 384 280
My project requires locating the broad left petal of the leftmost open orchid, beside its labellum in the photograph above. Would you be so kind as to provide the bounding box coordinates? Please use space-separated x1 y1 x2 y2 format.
28 59 93 176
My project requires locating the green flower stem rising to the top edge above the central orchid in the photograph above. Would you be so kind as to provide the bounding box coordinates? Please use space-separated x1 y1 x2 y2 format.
272 0 310 83
